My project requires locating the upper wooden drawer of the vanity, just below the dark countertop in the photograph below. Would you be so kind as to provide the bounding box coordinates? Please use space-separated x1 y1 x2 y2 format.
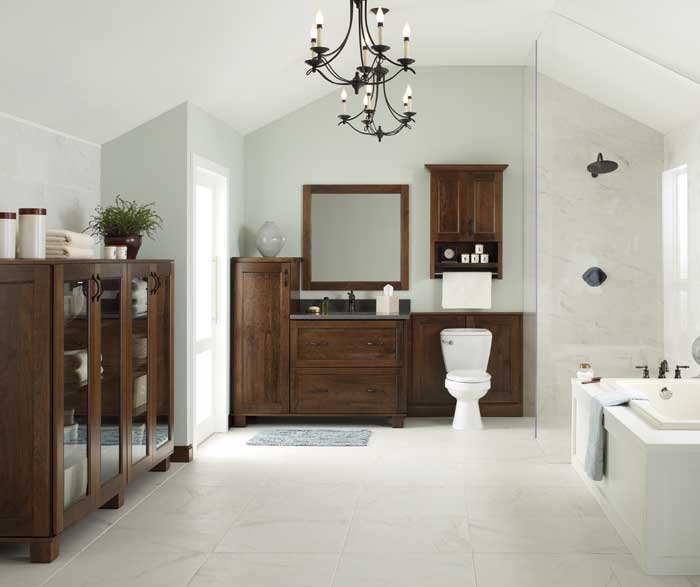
292 320 403 367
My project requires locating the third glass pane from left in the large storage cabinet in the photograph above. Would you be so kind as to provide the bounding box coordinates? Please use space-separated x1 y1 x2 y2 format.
131 277 149 463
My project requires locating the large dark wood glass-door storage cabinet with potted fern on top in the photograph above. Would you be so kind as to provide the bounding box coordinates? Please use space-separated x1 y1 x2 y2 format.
0 260 173 562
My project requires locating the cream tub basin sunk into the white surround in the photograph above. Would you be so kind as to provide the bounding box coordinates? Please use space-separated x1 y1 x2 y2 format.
616 379 700 430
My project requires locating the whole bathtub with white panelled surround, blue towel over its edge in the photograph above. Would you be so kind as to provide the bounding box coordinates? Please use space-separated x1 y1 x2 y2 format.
571 379 700 575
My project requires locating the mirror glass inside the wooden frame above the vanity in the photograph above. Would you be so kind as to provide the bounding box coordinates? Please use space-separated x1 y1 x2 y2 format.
311 193 401 282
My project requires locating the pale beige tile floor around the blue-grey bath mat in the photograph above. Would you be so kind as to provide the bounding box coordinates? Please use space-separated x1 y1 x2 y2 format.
0 419 700 587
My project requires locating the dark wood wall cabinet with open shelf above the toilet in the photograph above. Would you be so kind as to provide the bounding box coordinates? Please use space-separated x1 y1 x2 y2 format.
426 165 508 278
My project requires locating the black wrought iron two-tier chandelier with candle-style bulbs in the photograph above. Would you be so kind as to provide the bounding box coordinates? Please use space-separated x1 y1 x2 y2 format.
306 0 416 142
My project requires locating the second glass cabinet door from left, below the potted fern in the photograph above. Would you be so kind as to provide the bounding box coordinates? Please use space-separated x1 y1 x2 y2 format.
95 263 131 505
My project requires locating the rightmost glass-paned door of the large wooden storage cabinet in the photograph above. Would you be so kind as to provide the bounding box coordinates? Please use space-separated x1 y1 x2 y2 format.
151 263 175 464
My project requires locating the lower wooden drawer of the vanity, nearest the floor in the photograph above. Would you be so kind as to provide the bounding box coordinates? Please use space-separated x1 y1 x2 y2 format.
292 369 400 415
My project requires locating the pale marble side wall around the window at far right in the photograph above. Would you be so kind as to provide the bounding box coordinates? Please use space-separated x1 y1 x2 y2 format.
663 120 700 377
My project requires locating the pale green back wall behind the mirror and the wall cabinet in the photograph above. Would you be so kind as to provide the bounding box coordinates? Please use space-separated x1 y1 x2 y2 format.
243 67 523 311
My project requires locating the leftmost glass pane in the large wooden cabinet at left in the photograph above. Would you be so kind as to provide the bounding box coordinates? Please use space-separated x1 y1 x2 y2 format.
63 278 90 509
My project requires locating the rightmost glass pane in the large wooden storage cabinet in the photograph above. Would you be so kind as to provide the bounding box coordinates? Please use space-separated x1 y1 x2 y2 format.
156 275 172 448
